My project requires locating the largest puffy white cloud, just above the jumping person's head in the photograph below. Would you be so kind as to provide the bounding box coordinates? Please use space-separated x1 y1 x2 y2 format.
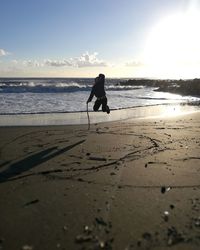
44 52 108 68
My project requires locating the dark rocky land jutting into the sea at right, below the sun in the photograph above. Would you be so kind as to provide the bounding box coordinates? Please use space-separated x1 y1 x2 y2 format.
120 78 200 97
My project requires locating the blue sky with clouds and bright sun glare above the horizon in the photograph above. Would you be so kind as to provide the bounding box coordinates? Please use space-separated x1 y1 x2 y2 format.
0 0 200 78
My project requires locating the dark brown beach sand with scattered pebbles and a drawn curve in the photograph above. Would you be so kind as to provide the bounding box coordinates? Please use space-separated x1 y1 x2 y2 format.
0 113 200 250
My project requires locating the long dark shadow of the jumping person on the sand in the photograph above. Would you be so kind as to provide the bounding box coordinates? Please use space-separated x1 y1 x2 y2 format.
0 140 85 183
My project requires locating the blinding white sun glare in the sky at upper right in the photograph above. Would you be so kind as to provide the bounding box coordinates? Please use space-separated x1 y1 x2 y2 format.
144 10 200 77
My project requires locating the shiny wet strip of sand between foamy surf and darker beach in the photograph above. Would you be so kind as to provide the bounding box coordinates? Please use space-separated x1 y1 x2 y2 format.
0 104 200 126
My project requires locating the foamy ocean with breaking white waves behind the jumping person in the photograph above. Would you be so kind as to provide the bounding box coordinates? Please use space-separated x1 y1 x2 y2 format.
0 78 200 115
